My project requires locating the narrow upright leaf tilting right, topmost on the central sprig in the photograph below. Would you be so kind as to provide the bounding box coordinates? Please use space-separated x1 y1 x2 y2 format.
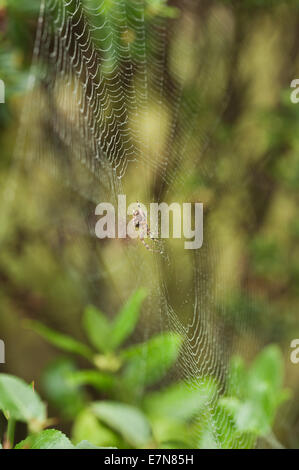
111 289 147 350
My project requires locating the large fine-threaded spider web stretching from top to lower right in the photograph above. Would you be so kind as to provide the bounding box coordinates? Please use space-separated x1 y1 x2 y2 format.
9 0 268 447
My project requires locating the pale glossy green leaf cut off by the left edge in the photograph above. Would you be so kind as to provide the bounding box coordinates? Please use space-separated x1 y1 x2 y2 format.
0 374 46 428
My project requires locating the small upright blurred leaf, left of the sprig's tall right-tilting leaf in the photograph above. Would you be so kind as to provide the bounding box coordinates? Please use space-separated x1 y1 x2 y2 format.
83 306 112 352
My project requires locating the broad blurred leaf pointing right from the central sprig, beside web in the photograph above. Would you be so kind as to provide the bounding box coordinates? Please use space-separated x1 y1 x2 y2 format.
121 333 182 389
